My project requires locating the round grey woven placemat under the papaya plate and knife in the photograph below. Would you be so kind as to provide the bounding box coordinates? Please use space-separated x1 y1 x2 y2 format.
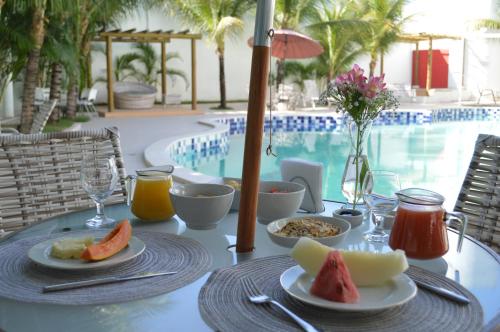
0 230 212 305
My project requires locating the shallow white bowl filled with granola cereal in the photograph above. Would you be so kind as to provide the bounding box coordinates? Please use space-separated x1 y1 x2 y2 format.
267 216 351 248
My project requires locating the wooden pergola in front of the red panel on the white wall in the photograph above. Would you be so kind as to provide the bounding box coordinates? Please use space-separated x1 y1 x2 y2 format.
398 32 463 96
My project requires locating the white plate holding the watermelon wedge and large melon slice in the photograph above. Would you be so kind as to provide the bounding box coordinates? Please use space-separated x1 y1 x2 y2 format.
280 265 417 311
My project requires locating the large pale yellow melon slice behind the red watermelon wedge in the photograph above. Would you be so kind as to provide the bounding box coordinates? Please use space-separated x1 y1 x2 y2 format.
290 237 408 286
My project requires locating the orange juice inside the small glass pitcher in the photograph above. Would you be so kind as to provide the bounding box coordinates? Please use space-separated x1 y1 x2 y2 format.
131 176 175 221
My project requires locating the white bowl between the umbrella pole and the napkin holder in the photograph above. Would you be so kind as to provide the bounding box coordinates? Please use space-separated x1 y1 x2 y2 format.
257 181 305 225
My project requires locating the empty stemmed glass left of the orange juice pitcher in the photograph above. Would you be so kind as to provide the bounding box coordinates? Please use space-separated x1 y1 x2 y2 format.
80 155 118 228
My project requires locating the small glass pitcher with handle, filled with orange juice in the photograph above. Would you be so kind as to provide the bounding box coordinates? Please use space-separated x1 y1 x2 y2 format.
127 166 175 221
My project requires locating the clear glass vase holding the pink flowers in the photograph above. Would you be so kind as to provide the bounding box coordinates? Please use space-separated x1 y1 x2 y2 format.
342 118 373 208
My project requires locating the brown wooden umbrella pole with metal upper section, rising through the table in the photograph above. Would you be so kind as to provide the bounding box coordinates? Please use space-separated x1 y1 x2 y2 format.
236 0 275 252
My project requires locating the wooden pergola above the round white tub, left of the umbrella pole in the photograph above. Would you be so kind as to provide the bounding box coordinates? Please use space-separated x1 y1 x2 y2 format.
94 29 201 112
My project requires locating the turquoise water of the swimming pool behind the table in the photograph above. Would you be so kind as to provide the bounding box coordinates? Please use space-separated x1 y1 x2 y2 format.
177 120 500 207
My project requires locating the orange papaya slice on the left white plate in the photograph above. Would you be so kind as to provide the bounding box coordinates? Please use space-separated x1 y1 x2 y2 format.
80 219 132 261
